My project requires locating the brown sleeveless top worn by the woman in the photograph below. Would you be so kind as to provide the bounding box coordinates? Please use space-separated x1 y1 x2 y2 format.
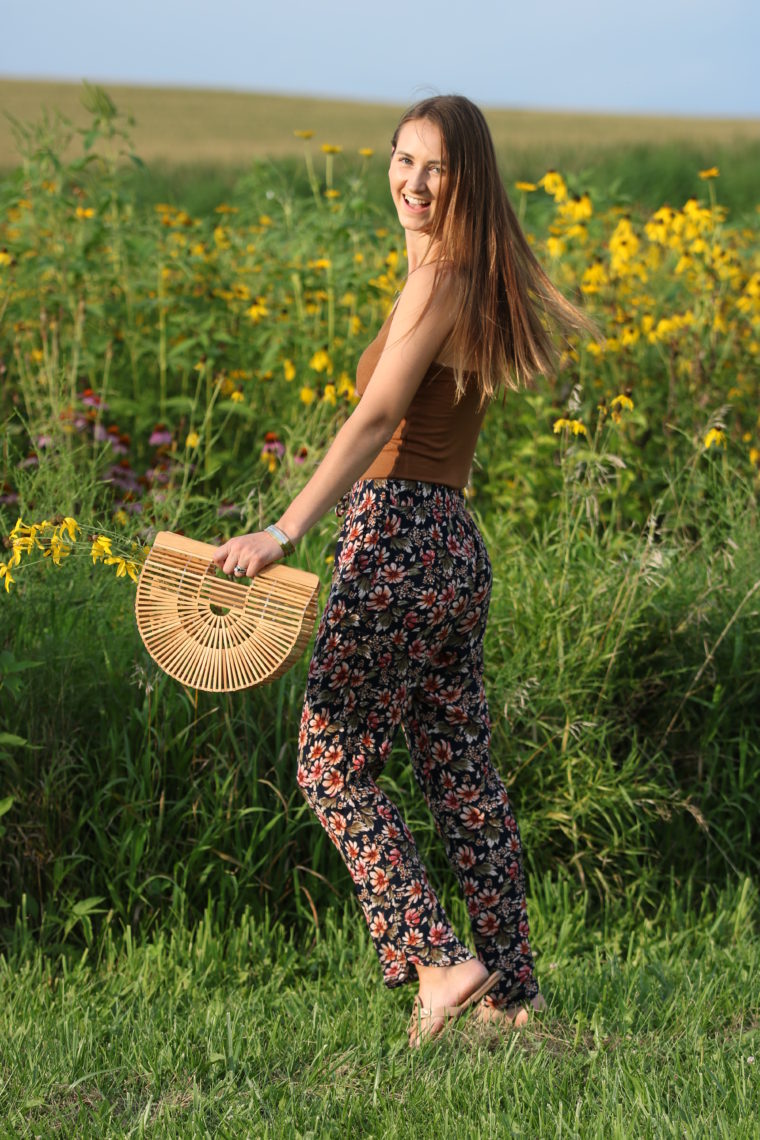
357 314 485 488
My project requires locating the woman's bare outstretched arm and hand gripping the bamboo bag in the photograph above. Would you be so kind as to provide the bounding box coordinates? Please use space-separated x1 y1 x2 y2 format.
214 264 455 577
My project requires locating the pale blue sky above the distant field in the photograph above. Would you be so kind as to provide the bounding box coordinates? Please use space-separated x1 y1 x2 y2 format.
0 0 760 117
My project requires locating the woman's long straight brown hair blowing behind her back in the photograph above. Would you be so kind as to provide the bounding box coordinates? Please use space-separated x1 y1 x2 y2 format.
392 95 596 400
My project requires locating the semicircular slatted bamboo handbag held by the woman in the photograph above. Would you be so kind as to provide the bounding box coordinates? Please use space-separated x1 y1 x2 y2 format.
134 530 319 693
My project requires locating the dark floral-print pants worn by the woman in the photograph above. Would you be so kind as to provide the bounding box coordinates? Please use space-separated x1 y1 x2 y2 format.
297 479 538 1007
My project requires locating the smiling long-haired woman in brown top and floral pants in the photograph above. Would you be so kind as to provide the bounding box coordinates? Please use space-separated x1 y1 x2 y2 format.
215 96 588 1045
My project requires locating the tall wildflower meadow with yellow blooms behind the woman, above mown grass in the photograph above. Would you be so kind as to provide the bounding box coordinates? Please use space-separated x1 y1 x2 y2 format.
0 89 760 942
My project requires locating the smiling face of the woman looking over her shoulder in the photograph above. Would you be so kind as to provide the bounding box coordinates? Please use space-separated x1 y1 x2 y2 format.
389 119 447 234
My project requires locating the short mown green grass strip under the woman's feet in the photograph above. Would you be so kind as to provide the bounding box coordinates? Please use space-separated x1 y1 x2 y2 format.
0 878 760 1140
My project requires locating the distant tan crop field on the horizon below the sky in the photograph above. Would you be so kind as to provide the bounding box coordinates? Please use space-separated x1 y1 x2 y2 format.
0 80 760 169
